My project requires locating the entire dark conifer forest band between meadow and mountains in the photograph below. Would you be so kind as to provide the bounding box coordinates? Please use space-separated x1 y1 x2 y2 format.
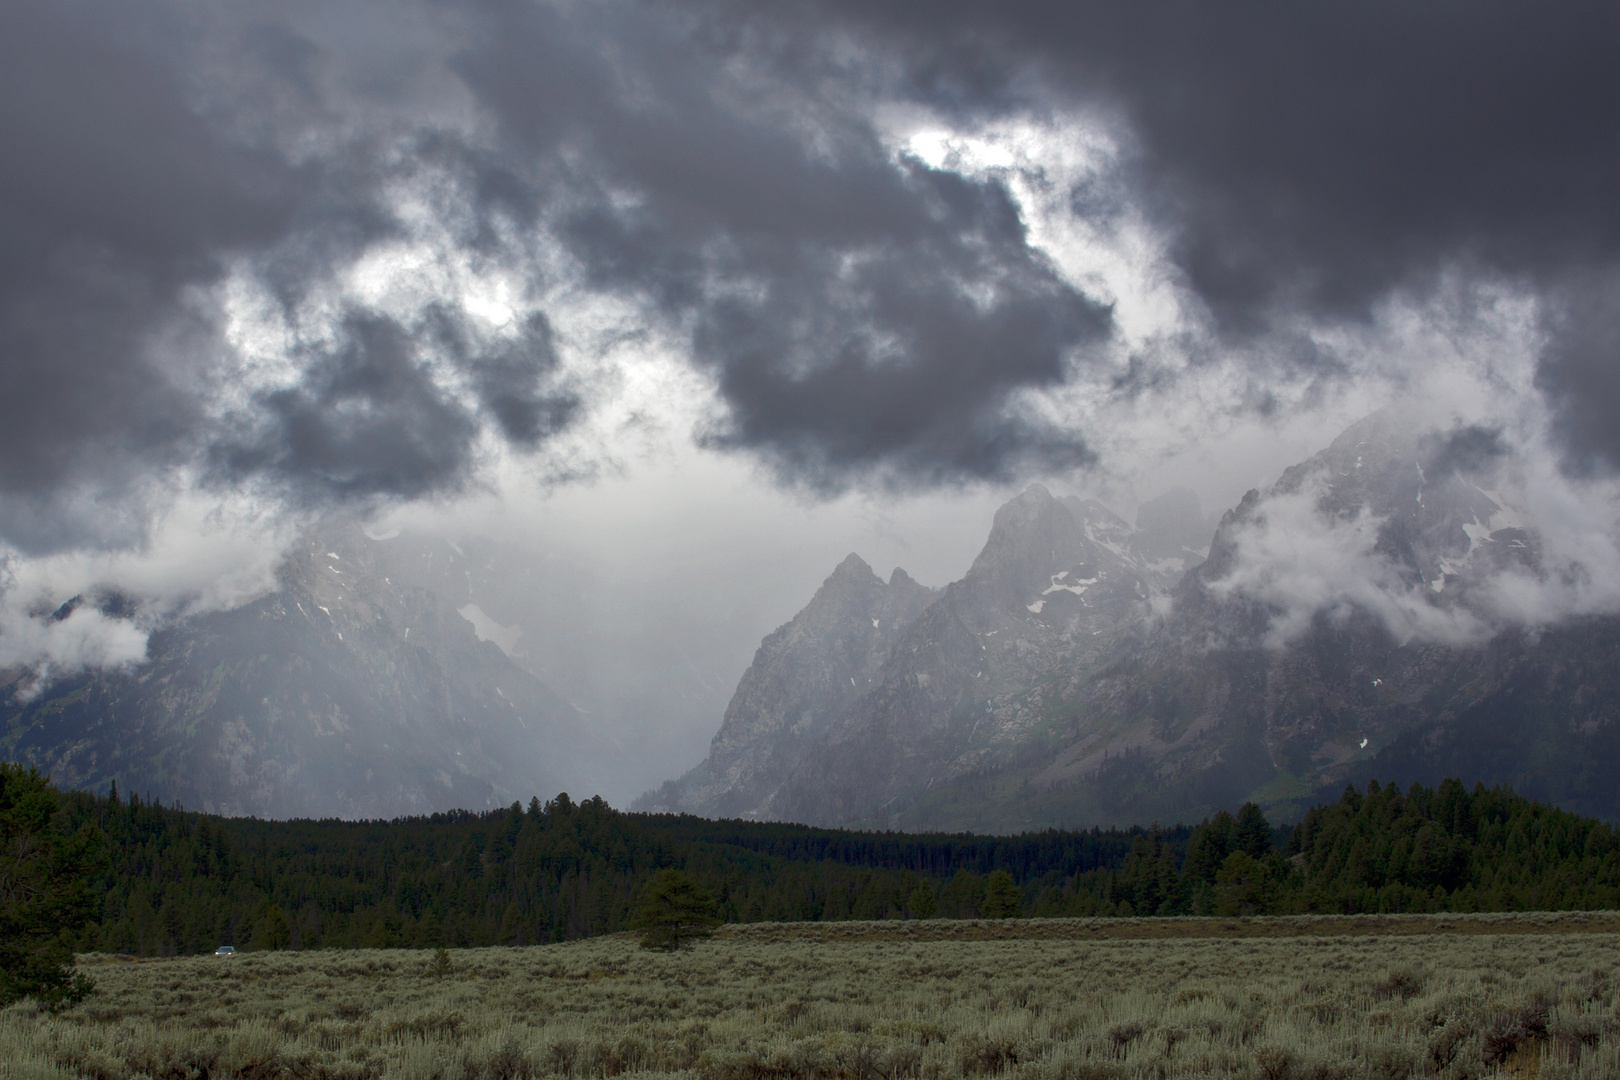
58 780 1620 955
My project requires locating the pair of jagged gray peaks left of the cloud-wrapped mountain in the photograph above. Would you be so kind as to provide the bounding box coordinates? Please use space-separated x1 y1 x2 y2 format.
640 484 1179 819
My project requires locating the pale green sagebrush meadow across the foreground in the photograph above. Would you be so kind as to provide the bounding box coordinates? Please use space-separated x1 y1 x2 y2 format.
0 913 1620 1080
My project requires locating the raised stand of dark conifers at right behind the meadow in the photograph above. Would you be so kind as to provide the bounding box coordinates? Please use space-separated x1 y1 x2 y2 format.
1025 780 1620 915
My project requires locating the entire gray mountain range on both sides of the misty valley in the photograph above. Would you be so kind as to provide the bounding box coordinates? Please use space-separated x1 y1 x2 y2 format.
9 415 1620 832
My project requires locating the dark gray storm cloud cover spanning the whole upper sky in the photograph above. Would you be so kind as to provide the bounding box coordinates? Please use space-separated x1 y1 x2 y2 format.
12 0 1620 557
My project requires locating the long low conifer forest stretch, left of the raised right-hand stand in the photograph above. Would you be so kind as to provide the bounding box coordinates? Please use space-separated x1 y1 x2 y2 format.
65 790 1192 955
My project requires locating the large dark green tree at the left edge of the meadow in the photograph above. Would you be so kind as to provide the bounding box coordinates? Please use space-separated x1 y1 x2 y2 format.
0 763 104 1009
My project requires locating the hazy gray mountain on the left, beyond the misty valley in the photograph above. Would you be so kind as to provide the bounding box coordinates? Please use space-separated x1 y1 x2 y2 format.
3 529 591 818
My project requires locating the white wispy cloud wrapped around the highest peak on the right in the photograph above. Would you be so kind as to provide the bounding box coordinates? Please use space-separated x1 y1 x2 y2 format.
1209 411 1620 648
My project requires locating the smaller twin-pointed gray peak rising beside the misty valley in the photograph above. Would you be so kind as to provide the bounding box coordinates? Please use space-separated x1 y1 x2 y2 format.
638 554 936 816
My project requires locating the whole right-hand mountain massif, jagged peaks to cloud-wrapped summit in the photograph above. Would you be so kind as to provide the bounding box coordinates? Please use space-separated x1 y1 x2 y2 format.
637 415 1620 832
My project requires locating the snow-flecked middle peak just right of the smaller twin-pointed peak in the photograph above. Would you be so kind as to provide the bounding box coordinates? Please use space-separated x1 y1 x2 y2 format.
771 484 1179 827
